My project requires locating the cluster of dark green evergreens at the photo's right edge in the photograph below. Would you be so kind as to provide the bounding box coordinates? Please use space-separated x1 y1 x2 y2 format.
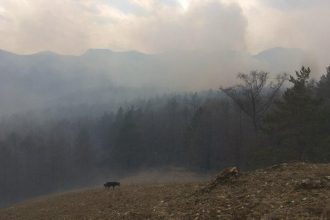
264 67 330 162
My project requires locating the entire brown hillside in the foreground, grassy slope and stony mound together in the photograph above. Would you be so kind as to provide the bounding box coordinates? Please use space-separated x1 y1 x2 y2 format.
0 163 330 220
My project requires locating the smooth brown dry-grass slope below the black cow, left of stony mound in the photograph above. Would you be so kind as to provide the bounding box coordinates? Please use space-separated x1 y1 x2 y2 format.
0 184 201 220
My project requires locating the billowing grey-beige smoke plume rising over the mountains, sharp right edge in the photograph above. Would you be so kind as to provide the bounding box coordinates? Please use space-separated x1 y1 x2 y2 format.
129 1 247 52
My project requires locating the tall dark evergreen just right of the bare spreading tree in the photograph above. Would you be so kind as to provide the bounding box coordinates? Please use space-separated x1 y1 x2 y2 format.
265 67 322 160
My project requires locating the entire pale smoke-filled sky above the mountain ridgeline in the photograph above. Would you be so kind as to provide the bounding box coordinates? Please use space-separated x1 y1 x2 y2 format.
0 0 330 65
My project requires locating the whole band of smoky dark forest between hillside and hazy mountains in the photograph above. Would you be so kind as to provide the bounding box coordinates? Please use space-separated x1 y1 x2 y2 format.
0 67 330 206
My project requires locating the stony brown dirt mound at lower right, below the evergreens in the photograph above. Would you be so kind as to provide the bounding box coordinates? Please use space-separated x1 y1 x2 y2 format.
180 163 330 219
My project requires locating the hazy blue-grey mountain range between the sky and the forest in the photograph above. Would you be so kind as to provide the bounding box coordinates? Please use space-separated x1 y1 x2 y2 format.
0 48 306 114
